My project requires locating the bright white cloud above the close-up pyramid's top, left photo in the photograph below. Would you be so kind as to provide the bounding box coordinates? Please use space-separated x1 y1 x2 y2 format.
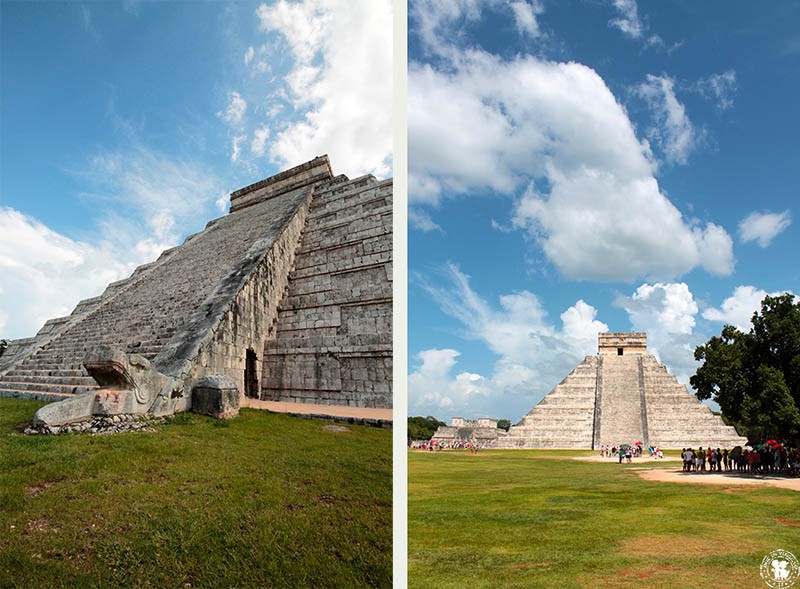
254 0 393 177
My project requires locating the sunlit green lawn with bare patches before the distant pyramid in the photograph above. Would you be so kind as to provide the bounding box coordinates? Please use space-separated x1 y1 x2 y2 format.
408 450 800 589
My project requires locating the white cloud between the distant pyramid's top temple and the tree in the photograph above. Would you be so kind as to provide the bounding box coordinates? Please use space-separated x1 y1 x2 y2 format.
616 282 706 384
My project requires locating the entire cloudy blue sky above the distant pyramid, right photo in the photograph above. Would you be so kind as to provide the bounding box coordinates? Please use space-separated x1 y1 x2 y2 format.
408 0 800 421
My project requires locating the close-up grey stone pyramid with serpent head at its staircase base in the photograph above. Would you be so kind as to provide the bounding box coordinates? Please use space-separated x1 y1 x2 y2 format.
0 156 392 423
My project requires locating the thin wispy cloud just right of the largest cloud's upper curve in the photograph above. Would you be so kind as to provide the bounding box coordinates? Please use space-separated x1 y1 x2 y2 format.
635 74 702 164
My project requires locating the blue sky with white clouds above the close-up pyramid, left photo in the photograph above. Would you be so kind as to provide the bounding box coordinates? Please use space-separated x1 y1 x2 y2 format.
0 0 392 338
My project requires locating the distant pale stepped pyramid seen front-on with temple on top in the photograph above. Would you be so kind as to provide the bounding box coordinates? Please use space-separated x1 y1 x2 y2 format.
493 332 747 449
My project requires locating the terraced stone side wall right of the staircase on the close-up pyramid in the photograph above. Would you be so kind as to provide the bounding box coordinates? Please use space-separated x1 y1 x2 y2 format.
261 176 392 407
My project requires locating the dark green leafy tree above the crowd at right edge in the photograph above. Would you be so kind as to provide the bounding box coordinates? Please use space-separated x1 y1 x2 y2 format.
690 293 800 441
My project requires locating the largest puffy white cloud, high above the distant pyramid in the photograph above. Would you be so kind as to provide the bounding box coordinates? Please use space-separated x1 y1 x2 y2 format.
408 50 733 280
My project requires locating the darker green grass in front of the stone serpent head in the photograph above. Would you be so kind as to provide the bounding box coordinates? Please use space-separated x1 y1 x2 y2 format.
0 399 392 589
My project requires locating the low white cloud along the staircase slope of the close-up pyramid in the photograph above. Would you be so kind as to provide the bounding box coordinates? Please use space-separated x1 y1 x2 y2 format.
0 146 223 338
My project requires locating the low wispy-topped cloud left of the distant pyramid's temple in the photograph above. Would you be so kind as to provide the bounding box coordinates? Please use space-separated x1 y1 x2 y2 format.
409 266 608 419
